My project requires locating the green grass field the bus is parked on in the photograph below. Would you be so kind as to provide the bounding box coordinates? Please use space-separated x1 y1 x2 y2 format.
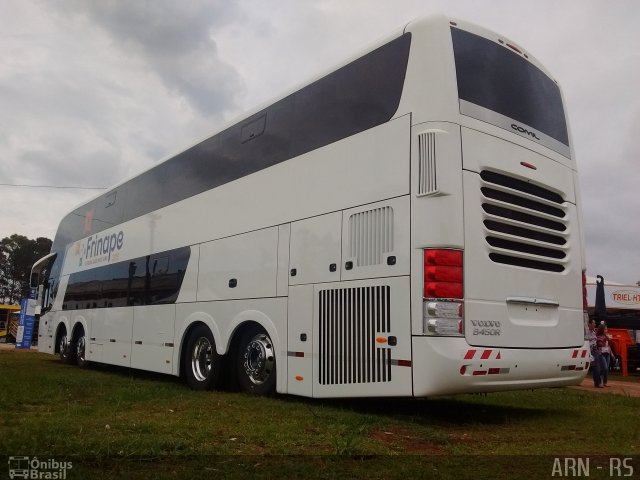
0 351 640 479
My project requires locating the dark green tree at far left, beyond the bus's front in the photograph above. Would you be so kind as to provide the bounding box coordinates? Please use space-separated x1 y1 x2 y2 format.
0 233 52 304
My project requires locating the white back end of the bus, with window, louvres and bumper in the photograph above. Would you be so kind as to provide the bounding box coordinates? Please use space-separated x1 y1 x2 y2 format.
412 16 590 396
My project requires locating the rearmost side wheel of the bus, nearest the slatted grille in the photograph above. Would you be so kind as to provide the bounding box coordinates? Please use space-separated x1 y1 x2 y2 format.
237 326 276 395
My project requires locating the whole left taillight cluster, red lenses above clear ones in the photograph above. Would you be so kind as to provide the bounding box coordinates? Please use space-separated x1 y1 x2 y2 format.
423 249 464 336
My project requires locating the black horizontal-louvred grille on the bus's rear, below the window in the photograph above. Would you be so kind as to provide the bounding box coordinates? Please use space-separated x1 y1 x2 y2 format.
480 171 569 272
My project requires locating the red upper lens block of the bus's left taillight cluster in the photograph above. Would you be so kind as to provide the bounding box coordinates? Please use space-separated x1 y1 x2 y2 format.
423 249 464 299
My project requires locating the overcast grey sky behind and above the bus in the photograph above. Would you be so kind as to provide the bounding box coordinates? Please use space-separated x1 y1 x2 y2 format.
0 0 640 284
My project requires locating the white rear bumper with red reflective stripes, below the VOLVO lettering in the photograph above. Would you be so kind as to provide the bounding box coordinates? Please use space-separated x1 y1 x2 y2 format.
412 336 591 397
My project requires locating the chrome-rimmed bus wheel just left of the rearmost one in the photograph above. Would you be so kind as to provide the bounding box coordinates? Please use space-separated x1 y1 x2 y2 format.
183 325 221 390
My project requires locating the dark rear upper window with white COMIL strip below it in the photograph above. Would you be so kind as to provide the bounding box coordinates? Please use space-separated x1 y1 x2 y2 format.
451 27 569 156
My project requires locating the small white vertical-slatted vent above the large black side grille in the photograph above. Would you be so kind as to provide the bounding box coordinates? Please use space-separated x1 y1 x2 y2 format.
349 207 393 267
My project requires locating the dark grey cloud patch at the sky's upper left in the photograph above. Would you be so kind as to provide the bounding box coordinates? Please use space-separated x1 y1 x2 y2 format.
49 0 242 118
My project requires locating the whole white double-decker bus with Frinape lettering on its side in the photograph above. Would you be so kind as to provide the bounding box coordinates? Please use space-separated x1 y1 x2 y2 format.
32 17 589 397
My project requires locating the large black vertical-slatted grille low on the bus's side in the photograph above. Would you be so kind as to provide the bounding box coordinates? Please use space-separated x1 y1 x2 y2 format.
318 286 391 385
